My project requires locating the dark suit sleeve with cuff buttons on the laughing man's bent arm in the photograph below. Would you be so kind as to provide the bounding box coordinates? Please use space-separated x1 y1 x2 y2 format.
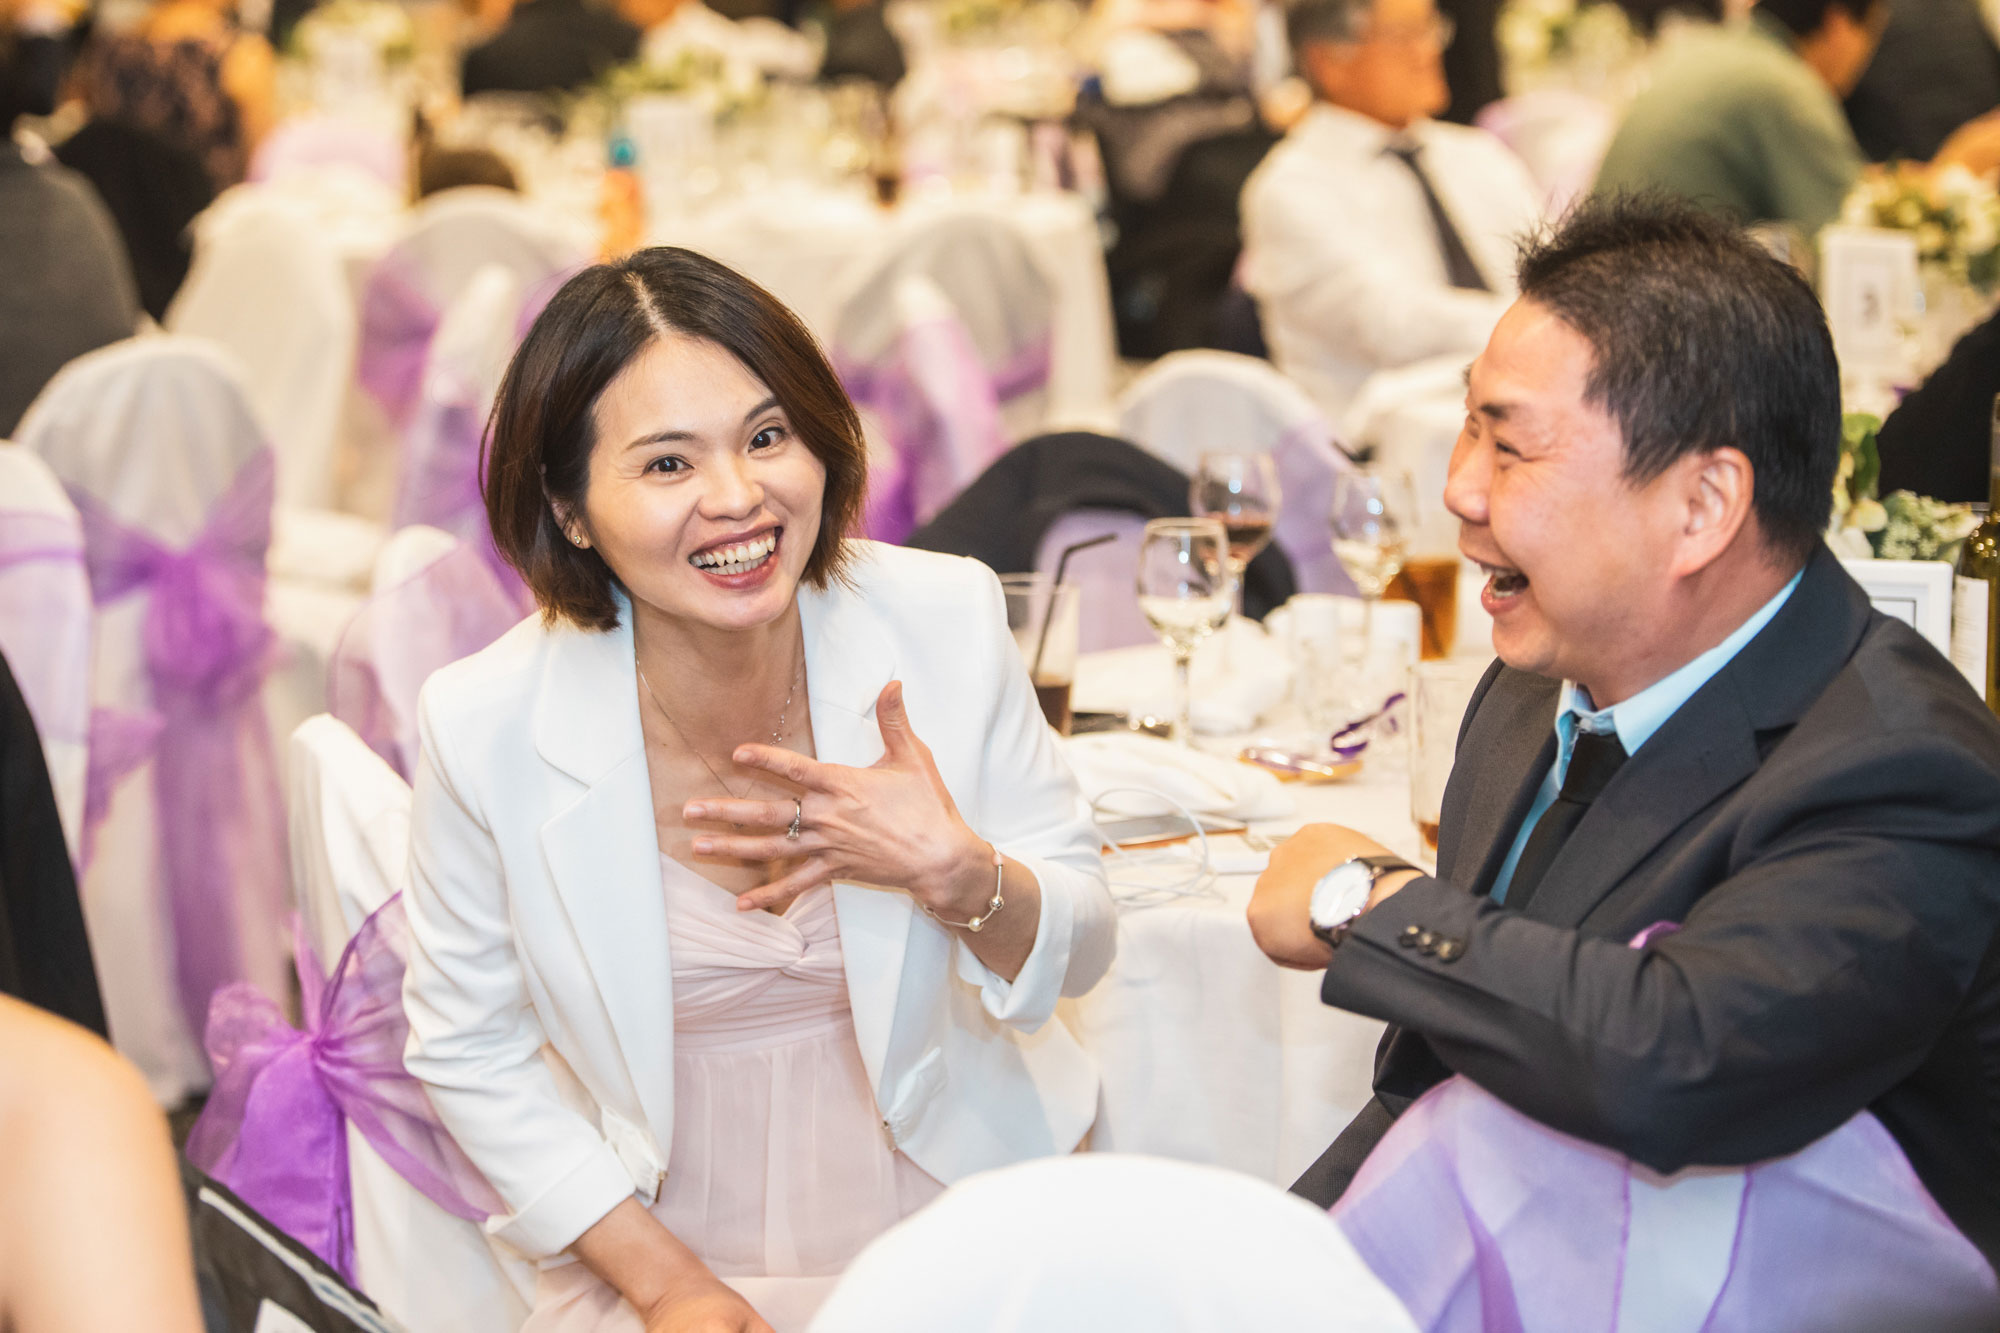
1322 720 2000 1171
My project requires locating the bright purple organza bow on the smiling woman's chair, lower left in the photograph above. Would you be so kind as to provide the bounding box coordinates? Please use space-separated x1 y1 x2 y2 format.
188 893 502 1283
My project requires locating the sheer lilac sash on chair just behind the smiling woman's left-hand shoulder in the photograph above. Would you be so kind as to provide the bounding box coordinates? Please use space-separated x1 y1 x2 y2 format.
326 534 532 781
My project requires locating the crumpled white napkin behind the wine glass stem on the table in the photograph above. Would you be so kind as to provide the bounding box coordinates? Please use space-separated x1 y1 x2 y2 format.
1070 616 1292 737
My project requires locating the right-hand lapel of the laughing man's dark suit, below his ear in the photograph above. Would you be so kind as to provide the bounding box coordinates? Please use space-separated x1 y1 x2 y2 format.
1526 546 1874 927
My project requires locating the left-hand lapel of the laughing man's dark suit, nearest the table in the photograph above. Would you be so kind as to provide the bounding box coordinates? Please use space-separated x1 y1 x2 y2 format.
1438 671 1562 895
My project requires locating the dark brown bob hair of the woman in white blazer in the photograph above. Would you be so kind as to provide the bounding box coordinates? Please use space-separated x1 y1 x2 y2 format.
482 246 868 628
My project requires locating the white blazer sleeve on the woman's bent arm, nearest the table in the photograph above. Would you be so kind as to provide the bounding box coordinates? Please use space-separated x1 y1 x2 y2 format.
952 568 1118 1020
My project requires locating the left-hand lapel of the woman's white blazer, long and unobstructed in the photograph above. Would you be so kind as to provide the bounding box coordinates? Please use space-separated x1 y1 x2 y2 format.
534 610 674 1127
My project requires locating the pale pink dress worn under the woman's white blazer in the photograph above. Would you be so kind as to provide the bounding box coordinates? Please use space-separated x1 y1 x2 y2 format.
522 857 944 1333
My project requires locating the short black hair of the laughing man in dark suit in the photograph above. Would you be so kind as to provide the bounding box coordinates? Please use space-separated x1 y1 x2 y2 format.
1520 194 1840 560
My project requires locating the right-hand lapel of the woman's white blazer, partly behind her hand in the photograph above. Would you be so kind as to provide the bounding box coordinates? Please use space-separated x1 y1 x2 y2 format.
798 582 916 1081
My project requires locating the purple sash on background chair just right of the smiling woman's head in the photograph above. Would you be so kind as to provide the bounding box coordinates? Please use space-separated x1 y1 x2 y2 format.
840 316 1050 542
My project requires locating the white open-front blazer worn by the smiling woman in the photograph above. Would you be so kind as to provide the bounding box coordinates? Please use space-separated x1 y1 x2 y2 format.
404 542 1116 1259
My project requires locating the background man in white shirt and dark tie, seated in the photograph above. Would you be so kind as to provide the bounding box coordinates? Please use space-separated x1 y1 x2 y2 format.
1242 0 1540 414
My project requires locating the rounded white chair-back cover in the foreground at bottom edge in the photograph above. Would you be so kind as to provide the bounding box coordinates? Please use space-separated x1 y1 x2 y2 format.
812 1153 1420 1333
